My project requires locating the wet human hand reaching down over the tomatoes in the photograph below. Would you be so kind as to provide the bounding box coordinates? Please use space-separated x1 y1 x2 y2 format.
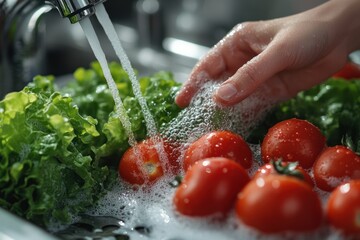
176 0 360 107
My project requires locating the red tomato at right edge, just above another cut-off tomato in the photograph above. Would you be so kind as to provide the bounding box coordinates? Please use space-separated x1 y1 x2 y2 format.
313 145 360 191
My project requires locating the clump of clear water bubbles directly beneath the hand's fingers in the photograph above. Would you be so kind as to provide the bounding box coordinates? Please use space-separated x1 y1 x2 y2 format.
161 81 273 148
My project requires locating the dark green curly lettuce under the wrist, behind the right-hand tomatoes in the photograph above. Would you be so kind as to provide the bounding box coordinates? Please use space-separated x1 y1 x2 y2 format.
250 78 360 151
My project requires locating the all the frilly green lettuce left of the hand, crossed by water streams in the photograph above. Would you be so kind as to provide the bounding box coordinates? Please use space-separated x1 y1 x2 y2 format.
0 62 180 226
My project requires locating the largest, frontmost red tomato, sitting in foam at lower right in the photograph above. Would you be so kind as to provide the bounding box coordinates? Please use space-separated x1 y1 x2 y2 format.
236 174 323 233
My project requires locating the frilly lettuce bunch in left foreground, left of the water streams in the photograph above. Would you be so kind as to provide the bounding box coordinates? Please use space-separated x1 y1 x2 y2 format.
0 76 110 225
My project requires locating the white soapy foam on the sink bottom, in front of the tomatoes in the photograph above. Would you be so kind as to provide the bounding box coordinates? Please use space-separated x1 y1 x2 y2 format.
89 169 340 240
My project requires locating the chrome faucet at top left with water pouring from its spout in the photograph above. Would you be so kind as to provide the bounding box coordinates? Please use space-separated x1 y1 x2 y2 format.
0 0 105 99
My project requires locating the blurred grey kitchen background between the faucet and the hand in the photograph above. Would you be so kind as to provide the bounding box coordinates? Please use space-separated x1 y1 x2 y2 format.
42 0 325 81
